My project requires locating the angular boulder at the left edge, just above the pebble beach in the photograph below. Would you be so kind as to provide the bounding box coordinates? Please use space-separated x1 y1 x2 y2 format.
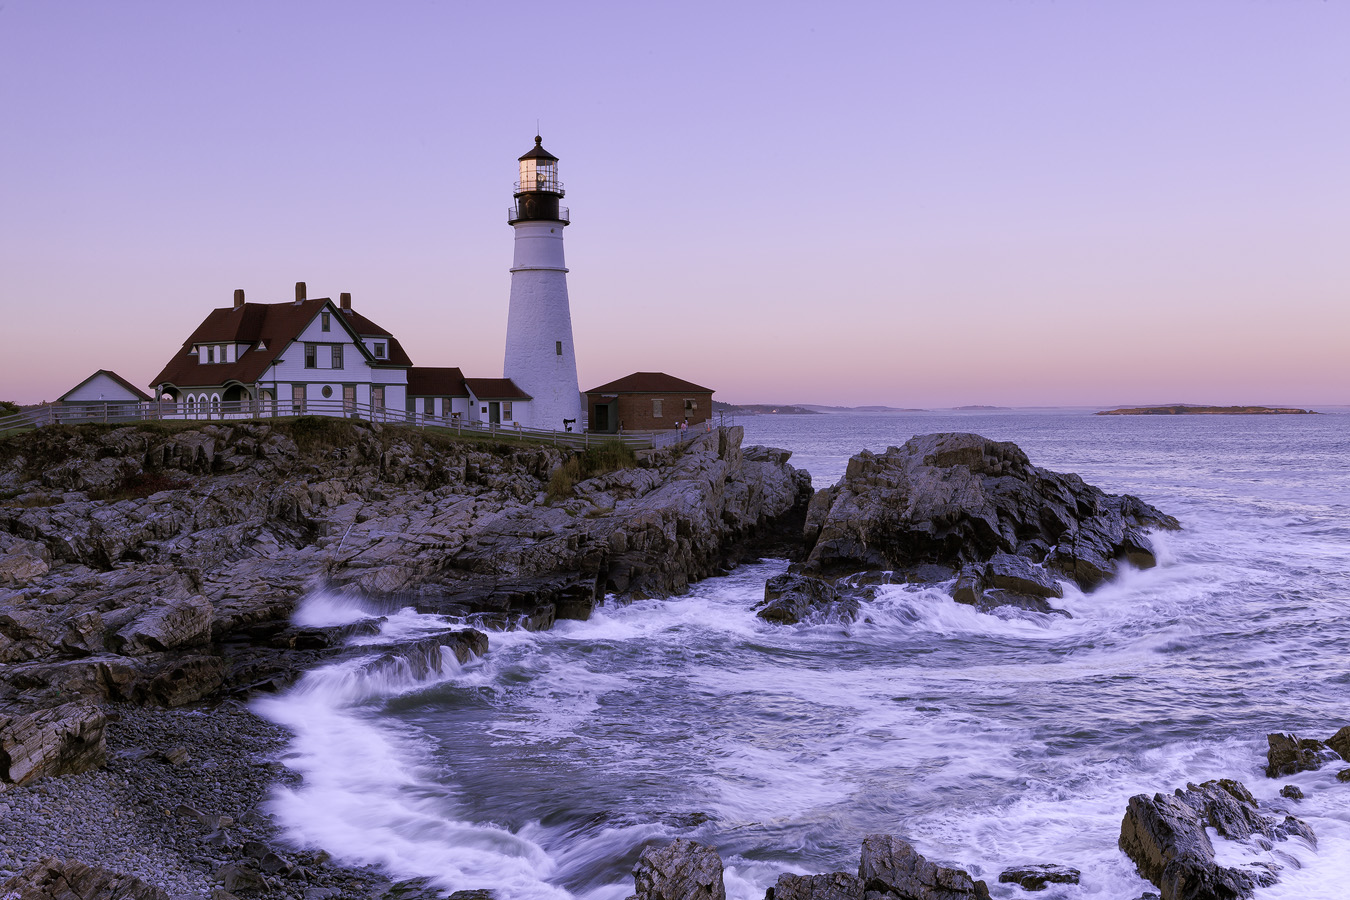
0 702 107 784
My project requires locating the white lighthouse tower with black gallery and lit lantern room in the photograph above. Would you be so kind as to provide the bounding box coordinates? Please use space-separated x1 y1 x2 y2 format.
502 135 582 430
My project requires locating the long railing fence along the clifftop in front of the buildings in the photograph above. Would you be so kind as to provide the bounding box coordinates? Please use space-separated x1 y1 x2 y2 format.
0 399 728 449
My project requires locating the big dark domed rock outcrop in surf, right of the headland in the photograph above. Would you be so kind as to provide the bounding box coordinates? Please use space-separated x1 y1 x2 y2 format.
801 434 1179 611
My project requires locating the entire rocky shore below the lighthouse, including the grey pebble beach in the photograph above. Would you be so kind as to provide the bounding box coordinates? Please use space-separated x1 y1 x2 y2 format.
0 418 810 900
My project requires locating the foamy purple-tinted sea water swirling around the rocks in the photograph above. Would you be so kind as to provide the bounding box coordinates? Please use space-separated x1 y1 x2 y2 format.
257 410 1350 900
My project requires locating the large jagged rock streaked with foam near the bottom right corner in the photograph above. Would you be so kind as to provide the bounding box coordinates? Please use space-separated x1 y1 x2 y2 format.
1121 779 1316 900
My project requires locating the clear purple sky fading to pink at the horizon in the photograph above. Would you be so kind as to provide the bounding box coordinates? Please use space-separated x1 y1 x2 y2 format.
0 0 1350 407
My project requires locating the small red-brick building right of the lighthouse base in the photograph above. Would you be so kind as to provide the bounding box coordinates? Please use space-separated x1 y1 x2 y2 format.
586 372 713 434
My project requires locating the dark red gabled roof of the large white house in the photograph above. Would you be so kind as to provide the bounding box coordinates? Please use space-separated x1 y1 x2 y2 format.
151 297 412 387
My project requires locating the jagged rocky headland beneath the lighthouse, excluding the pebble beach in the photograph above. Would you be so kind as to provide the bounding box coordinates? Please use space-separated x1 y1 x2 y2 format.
0 418 810 784
